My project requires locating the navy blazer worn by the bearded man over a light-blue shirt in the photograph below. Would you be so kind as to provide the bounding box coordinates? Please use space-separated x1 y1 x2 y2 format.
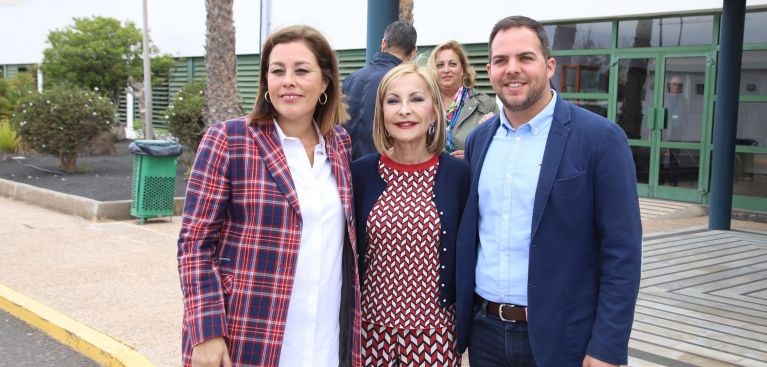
456 98 642 367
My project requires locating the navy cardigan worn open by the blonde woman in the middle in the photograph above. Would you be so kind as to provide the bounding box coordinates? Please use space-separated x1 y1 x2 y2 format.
351 153 469 307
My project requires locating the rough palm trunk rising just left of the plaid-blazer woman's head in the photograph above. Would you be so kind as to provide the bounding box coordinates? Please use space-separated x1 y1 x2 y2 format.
205 0 242 125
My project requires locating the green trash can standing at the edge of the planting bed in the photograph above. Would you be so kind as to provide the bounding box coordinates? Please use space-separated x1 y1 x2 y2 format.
129 140 182 224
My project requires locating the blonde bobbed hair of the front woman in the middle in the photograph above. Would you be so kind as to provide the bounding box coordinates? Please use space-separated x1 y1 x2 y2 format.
373 62 447 154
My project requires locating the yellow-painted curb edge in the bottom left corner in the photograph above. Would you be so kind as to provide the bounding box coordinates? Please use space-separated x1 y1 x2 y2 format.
0 284 153 367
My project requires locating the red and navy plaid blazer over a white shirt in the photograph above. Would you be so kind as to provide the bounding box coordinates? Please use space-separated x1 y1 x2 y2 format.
178 117 362 366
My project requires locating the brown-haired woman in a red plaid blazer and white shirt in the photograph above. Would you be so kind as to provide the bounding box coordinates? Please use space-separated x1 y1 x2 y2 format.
178 26 361 366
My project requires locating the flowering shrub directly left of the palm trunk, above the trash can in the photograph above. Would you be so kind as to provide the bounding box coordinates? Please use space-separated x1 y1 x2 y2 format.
165 82 207 156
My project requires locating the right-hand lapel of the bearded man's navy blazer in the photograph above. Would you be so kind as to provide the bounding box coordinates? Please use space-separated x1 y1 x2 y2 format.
530 96 570 238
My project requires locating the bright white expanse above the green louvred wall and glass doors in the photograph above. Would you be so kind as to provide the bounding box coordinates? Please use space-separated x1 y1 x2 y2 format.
0 0 767 65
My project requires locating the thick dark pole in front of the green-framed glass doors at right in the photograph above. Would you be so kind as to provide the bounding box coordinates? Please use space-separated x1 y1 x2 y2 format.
708 0 746 230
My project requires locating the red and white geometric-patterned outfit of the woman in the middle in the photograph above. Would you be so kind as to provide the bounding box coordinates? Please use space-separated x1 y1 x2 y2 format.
361 155 460 366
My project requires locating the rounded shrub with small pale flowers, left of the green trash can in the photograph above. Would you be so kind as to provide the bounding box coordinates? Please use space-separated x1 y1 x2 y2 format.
11 86 115 173
